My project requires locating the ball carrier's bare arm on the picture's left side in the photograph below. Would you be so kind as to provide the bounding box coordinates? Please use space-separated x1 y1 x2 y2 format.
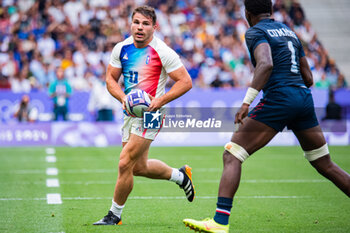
106 64 126 104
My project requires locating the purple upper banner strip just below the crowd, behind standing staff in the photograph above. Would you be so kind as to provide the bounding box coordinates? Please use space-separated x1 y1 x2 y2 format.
0 88 350 124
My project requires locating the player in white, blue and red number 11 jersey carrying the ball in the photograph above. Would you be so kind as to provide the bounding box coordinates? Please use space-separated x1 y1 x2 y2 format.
94 6 195 225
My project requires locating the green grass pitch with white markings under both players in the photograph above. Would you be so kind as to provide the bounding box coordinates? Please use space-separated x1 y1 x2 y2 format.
0 146 350 233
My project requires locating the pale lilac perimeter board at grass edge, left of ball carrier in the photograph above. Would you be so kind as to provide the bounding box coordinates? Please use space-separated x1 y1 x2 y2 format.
0 122 121 147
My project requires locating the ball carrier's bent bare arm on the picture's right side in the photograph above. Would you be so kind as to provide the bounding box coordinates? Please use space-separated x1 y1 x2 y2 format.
148 66 192 111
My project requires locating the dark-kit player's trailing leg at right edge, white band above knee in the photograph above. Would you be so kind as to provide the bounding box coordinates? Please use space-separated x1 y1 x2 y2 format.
293 126 350 197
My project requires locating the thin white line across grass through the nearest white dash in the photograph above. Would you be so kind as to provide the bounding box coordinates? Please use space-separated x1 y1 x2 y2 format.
0 193 312 204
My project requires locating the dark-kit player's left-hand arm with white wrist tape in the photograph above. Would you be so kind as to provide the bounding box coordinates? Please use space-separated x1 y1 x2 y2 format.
235 43 273 123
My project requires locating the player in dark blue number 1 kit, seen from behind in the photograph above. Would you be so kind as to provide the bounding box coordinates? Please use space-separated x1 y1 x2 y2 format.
183 0 350 232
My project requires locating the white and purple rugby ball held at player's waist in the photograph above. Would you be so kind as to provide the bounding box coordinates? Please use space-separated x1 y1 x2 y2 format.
125 89 151 117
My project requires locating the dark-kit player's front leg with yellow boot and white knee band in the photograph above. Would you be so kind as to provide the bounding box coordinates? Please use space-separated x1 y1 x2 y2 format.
184 118 278 232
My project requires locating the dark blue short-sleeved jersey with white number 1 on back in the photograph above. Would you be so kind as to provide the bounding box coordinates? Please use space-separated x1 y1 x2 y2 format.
245 19 306 93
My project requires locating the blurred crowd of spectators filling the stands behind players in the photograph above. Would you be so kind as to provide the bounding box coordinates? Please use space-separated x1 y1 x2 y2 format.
0 0 347 93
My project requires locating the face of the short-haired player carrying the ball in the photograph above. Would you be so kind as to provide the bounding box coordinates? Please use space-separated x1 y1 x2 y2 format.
131 13 156 47
